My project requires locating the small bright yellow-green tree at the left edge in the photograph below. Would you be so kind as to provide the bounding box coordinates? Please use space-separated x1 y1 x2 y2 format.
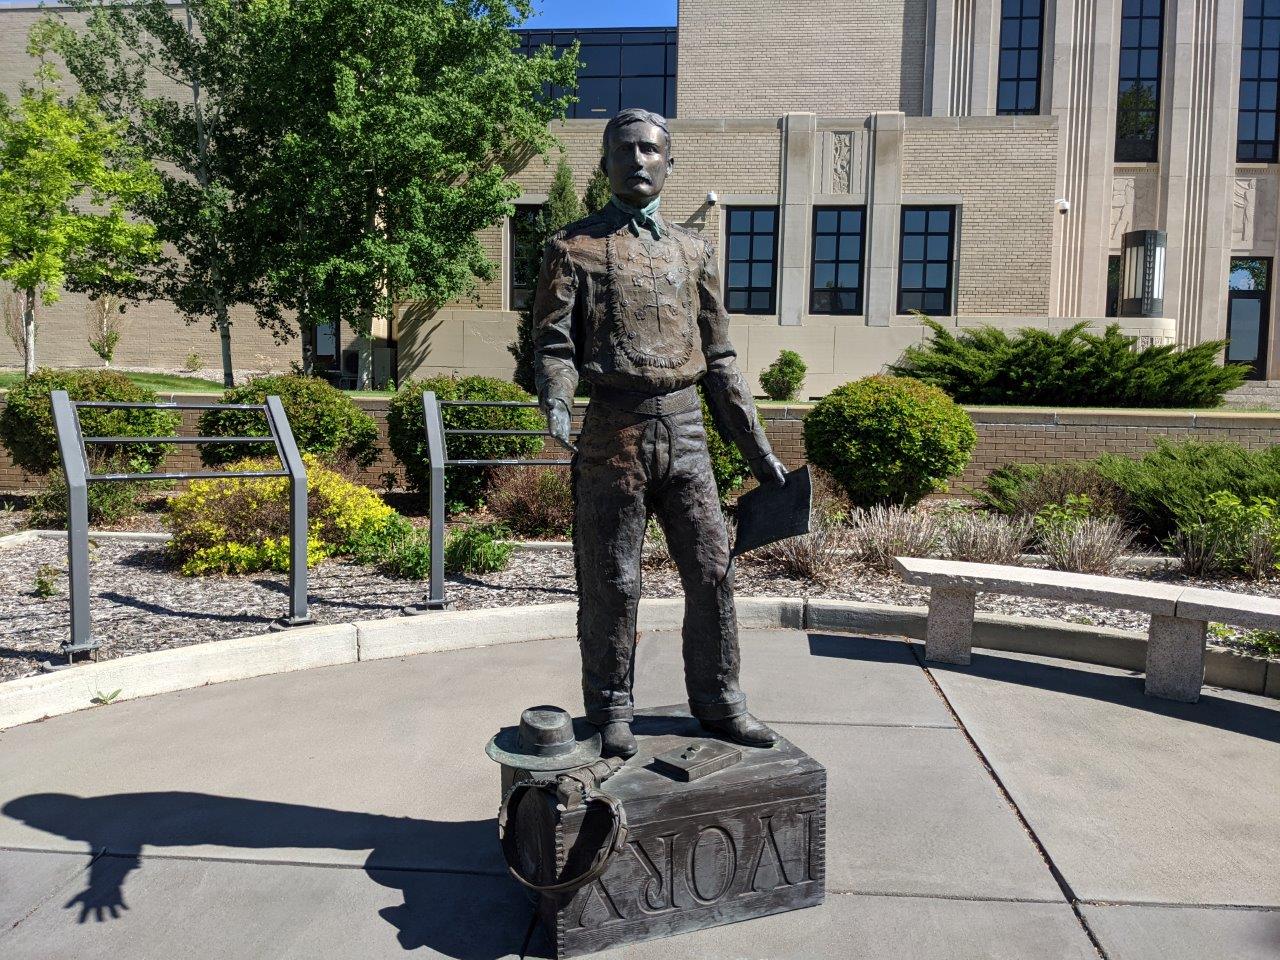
0 23 159 376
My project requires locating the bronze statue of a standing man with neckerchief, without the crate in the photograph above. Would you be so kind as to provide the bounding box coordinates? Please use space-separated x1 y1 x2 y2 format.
534 110 786 756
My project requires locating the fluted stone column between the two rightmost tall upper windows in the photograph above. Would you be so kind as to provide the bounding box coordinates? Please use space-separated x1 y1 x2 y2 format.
1160 0 1243 344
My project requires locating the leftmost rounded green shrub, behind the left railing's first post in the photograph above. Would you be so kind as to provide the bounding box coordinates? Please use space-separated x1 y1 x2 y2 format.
0 369 182 474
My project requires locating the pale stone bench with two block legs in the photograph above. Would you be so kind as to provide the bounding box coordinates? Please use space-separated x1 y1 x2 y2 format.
893 557 1280 703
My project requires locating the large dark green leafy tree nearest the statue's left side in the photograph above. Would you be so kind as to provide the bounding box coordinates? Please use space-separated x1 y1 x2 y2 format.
236 0 577 385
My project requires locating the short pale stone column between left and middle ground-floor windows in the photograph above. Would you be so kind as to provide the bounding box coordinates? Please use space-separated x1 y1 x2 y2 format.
778 114 818 326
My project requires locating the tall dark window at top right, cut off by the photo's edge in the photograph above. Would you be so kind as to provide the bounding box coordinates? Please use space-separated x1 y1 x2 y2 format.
1235 0 1280 164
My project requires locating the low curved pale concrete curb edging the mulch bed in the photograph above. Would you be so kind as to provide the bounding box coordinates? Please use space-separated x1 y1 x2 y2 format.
0 596 1280 730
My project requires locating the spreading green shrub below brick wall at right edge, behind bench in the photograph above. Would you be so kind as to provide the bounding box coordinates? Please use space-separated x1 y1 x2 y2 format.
1096 440 1280 543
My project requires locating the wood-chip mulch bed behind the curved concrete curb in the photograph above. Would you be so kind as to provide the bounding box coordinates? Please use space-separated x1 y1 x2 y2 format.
0 540 1280 681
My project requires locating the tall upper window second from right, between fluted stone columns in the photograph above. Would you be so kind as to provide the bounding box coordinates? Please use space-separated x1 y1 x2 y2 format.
1116 0 1165 163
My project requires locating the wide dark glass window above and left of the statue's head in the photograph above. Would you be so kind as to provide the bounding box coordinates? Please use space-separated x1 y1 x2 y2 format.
517 28 676 118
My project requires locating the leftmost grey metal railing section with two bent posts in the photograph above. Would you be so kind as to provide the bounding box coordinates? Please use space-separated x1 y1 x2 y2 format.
50 390 312 664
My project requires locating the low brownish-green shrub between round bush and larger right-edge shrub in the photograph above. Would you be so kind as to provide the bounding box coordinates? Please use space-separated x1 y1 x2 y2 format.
978 461 1128 517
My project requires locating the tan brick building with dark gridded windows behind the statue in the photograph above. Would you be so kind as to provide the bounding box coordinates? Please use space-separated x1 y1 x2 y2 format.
0 0 1280 396
